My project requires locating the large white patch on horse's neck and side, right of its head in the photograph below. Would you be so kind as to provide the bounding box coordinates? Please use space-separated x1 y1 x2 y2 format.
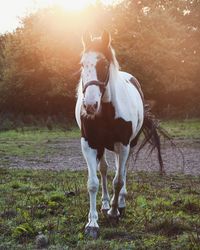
103 63 144 140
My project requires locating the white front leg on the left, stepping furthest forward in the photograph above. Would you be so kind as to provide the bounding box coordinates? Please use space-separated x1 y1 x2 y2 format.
81 138 99 239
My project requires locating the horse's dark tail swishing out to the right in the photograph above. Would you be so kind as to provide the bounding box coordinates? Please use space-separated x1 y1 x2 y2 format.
136 105 175 174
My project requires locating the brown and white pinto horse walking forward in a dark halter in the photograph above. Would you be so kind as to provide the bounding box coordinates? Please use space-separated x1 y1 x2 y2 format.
75 31 165 239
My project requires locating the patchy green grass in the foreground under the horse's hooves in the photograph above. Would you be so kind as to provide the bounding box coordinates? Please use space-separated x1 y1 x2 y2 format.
0 168 200 250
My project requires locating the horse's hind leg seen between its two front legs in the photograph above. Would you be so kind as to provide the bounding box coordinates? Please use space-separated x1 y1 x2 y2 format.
99 156 110 214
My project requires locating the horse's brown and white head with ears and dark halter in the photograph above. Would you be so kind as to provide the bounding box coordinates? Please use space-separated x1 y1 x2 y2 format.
81 31 112 116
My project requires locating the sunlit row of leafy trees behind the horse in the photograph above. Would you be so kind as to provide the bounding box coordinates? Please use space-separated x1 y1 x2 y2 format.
0 0 200 117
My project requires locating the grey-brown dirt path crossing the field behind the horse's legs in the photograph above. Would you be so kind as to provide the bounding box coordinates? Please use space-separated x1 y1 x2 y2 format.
1 139 200 175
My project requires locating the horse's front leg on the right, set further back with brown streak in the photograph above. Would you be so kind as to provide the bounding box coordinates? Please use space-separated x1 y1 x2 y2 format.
108 143 130 222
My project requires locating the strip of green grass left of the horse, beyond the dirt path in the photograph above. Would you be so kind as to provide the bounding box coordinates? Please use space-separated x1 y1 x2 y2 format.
0 127 80 158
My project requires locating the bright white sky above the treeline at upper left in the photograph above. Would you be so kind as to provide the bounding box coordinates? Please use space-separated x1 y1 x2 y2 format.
0 0 117 34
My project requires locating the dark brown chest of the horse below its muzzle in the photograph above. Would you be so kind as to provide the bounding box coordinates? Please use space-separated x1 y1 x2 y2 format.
81 103 132 158
